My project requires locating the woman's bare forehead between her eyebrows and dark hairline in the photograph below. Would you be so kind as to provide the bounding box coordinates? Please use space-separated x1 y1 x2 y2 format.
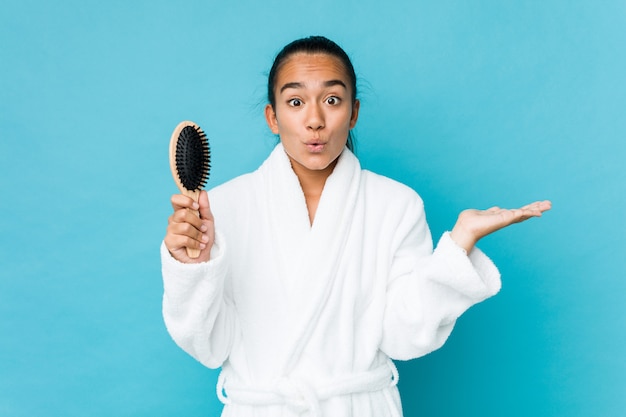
276 53 350 89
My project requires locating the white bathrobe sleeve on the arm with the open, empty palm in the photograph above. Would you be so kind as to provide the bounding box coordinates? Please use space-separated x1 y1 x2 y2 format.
381 194 501 360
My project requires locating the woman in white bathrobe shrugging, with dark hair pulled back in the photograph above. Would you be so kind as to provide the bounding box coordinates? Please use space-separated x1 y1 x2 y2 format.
161 37 550 417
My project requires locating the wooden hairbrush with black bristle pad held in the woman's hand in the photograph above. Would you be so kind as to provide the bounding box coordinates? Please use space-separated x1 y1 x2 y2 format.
170 121 211 258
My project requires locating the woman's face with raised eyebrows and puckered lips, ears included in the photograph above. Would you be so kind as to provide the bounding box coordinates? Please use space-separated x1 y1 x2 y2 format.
265 53 359 176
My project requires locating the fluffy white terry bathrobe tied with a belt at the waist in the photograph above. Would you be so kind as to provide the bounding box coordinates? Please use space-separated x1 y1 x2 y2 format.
161 144 500 417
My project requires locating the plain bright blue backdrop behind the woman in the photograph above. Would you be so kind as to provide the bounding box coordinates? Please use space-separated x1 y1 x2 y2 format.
0 0 626 417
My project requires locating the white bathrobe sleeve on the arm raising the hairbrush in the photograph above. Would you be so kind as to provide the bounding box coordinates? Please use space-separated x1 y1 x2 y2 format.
161 233 237 368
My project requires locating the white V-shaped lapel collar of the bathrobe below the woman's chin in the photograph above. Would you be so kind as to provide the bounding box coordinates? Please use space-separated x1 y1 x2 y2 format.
263 144 361 376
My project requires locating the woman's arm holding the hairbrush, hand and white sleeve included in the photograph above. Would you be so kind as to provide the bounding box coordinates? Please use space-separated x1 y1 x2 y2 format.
161 192 237 368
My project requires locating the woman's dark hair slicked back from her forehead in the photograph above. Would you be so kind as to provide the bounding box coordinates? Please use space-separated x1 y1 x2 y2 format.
267 36 357 151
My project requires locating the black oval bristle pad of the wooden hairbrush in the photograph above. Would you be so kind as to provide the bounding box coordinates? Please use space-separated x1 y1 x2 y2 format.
176 126 211 191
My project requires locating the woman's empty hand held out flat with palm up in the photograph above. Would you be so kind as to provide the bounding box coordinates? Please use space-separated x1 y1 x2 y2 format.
450 200 552 253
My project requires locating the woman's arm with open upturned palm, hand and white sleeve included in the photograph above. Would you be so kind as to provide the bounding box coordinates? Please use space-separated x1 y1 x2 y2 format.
381 197 551 359
